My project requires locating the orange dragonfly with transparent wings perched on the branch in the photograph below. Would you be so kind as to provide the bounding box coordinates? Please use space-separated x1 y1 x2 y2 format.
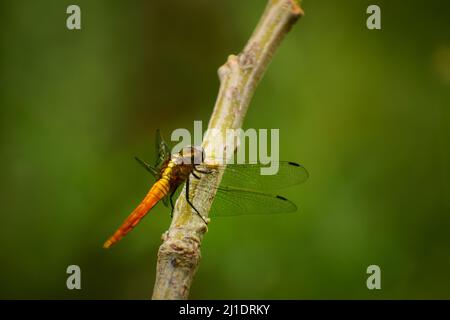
103 130 309 249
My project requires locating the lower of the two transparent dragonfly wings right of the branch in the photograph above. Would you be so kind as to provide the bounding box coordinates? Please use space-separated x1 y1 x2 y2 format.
207 187 297 216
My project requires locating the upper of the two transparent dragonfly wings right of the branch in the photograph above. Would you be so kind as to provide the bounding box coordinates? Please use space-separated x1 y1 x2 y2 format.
203 161 309 191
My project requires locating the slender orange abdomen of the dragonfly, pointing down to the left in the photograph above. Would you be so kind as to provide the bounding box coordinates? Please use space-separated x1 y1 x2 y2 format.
103 178 170 249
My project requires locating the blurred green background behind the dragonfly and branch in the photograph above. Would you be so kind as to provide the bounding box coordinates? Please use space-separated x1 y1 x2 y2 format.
0 0 450 299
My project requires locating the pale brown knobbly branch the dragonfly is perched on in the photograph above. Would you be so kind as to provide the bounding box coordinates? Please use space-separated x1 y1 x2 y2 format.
153 0 303 299
